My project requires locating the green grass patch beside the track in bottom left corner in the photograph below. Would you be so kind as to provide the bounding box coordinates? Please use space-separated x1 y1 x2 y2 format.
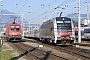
0 43 15 60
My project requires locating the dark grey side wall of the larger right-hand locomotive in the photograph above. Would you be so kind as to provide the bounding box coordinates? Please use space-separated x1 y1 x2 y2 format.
40 21 54 39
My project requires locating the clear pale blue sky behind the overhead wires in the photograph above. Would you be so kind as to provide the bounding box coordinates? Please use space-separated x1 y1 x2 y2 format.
0 0 90 22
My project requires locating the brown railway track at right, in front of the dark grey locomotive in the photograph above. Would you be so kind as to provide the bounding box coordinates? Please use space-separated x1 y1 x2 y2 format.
56 46 90 60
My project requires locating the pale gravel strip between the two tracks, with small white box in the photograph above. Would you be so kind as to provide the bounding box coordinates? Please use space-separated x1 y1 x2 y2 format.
24 42 81 60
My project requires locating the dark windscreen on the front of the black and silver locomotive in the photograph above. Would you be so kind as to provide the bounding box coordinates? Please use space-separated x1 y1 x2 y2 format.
56 18 72 31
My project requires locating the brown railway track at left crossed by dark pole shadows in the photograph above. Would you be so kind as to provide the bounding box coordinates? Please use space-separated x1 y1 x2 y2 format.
9 43 68 60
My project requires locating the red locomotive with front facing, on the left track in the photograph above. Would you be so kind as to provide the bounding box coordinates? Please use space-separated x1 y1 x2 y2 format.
5 22 22 41
